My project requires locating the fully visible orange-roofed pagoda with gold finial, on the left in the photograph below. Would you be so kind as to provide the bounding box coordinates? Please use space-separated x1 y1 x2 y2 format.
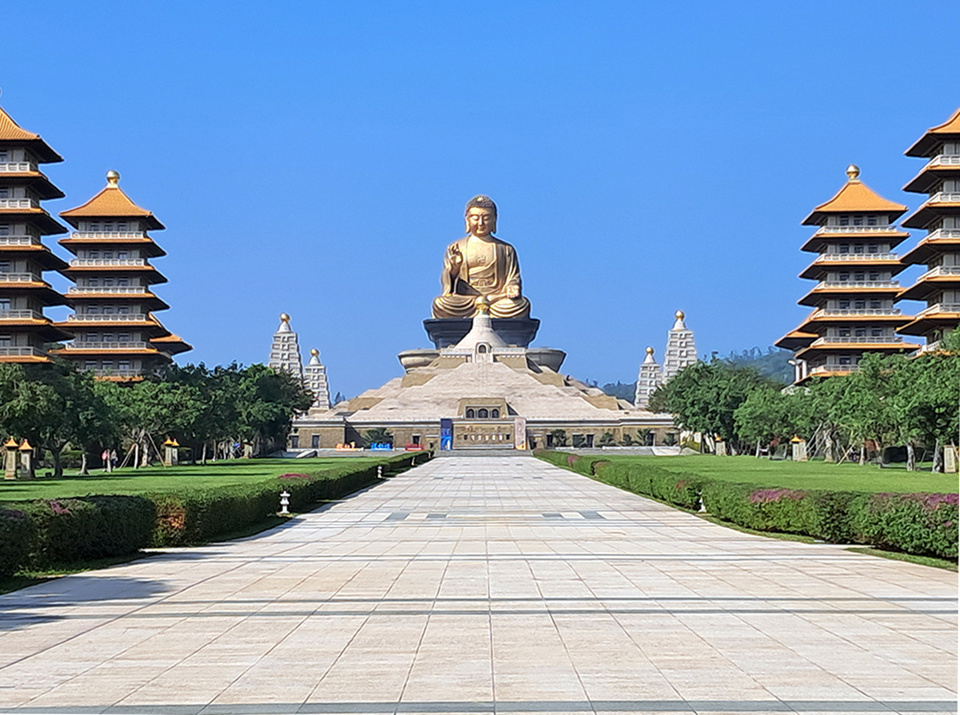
52 171 191 380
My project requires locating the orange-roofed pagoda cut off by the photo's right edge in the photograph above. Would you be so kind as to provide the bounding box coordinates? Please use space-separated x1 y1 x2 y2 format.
897 109 960 351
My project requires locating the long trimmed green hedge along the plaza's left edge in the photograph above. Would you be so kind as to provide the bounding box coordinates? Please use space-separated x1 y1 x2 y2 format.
0 452 432 577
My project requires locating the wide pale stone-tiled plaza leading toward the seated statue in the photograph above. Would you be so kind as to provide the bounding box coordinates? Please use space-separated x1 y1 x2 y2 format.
0 456 957 715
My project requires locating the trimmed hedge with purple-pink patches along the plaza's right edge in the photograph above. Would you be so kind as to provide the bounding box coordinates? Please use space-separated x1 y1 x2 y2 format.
535 450 958 560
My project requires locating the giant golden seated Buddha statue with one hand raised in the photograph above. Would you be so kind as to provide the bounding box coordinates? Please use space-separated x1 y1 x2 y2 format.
433 195 530 318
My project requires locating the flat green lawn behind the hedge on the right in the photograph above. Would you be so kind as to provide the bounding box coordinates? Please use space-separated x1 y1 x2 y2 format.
609 455 957 493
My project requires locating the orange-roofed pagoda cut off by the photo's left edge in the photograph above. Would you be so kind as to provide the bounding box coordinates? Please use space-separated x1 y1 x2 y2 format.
0 103 71 363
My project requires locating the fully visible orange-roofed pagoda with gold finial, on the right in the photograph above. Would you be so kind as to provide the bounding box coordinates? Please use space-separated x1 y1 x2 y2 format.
776 165 914 384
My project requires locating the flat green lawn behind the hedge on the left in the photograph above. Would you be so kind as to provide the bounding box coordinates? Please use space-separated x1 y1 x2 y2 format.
0 455 389 502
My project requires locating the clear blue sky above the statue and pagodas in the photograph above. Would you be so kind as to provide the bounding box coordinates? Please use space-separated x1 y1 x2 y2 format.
0 0 960 395
